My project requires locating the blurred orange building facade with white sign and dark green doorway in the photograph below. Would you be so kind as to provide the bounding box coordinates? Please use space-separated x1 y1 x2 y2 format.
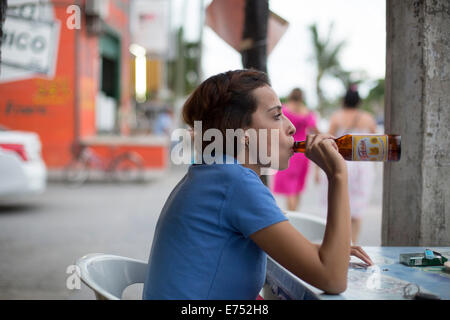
0 0 169 174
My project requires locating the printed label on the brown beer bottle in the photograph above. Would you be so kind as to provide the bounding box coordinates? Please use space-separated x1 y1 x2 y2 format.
352 135 388 161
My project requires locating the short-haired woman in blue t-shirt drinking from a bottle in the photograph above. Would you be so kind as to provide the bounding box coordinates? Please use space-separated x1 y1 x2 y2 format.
143 70 371 299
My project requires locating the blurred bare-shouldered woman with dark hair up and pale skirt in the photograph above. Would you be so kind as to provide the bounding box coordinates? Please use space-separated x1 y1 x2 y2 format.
329 85 377 244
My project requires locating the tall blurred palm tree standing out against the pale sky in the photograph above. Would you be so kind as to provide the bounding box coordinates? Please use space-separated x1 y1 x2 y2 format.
309 23 344 114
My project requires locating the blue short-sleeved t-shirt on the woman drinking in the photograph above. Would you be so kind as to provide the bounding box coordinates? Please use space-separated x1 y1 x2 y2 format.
143 157 287 300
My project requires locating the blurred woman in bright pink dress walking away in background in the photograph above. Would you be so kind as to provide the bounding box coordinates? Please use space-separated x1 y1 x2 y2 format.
273 88 319 211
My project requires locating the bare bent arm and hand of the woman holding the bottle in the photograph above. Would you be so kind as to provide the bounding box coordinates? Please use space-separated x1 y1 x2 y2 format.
250 134 351 294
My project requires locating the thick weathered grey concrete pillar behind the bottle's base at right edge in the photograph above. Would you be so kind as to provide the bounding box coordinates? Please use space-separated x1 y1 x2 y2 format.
382 0 450 246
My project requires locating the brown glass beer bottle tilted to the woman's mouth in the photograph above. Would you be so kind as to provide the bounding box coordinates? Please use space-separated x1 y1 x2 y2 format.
293 134 402 161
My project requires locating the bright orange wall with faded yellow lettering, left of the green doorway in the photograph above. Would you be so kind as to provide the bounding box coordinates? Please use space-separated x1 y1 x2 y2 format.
0 1 75 167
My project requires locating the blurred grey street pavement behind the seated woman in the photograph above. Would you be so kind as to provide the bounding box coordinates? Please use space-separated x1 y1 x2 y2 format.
0 164 382 299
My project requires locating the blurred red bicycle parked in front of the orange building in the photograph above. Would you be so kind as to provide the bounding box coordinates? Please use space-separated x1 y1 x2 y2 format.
64 144 144 185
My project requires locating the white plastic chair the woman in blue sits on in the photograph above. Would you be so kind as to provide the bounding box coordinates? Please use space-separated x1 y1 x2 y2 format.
76 253 147 300
